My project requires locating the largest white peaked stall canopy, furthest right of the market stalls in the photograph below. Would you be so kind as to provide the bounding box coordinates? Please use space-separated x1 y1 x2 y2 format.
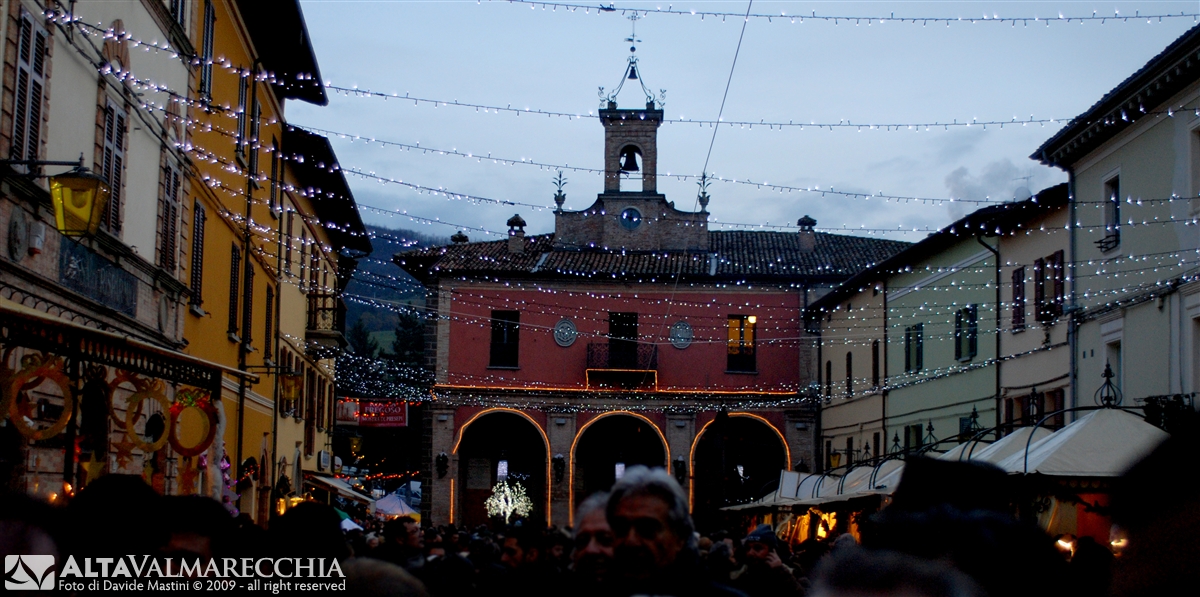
996 409 1168 477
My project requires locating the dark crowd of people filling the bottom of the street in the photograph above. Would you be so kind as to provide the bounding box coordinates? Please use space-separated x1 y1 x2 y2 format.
0 419 1200 597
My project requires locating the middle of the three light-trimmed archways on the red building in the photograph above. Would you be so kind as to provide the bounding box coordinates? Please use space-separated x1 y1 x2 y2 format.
571 412 668 513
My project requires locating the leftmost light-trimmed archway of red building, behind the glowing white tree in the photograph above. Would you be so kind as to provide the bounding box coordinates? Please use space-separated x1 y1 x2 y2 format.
452 410 548 526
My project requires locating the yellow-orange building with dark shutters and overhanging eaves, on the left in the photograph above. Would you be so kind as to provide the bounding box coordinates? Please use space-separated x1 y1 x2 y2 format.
181 0 370 523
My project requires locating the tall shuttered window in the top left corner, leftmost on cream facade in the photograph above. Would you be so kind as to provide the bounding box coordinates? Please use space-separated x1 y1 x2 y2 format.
10 11 47 159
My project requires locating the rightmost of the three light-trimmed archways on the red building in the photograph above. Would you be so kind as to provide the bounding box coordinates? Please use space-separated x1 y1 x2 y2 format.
691 412 790 529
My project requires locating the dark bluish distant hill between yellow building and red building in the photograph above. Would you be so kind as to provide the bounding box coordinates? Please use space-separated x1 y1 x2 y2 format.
346 225 450 350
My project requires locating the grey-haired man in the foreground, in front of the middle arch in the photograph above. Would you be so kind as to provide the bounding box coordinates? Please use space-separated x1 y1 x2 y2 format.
606 466 742 597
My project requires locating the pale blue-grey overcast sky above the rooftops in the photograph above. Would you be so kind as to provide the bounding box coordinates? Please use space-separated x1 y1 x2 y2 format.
287 0 1200 241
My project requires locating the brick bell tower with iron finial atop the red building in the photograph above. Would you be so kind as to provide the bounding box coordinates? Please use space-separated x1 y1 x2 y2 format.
600 102 662 194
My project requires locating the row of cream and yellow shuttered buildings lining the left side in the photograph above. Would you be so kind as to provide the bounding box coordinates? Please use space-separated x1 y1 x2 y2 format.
0 0 371 524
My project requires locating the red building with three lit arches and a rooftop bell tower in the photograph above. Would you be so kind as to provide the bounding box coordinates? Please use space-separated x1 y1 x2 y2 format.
395 85 906 525
